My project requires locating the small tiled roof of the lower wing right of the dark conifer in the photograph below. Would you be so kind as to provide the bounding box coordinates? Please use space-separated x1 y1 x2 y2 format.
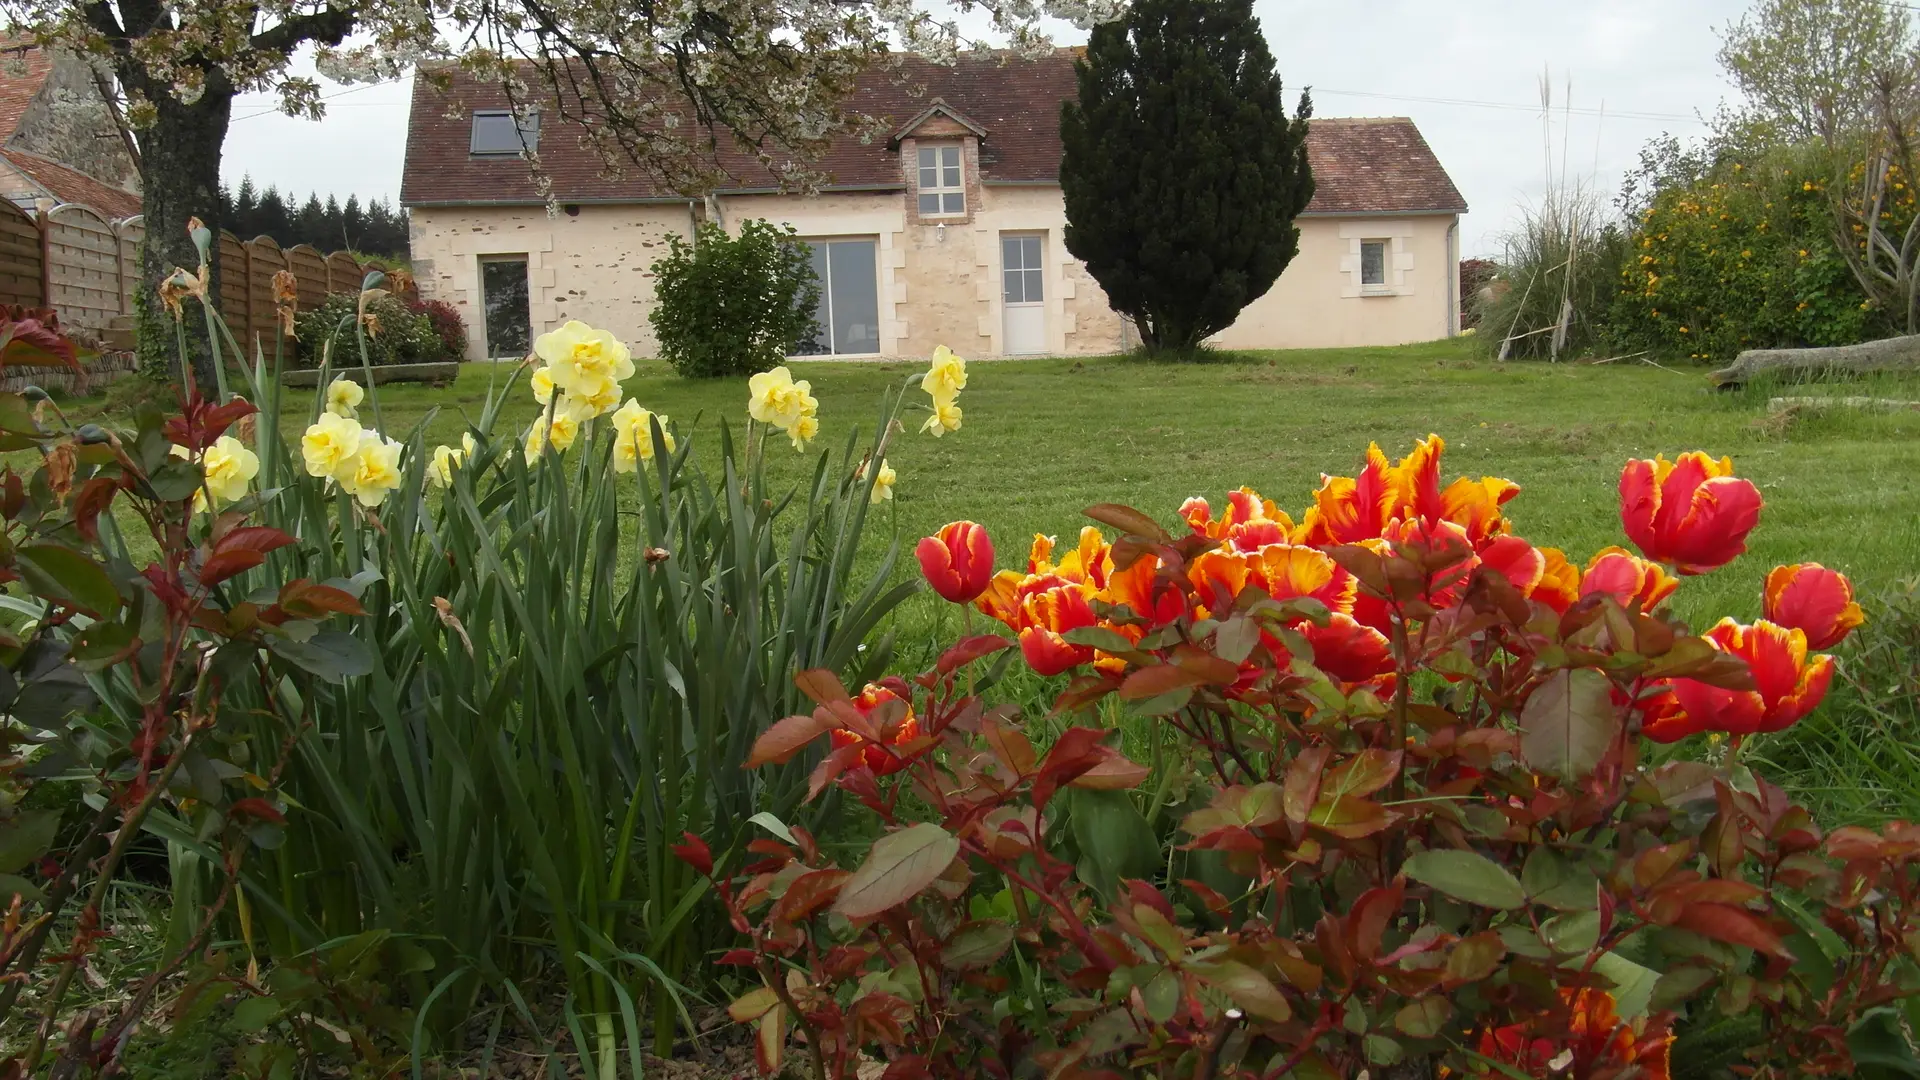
1308 117 1467 213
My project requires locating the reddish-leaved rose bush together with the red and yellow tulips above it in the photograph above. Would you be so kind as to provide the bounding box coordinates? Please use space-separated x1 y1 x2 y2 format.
678 438 1920 1080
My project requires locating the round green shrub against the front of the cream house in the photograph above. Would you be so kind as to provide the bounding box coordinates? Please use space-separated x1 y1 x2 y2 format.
649 221 820 379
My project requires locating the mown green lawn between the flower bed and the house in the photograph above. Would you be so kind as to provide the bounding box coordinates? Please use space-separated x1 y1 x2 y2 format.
330 340 1920 619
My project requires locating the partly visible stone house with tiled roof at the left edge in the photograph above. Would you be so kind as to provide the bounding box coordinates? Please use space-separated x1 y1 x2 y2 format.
0 40 140 219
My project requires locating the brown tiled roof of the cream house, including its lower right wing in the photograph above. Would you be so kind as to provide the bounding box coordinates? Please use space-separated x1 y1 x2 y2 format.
399 48 1467 213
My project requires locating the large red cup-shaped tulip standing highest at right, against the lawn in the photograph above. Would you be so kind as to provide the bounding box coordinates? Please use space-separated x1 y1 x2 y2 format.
1620 450 1761 575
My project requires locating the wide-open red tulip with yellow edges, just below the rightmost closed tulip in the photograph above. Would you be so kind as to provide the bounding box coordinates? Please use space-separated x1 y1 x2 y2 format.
1663 619 1834 742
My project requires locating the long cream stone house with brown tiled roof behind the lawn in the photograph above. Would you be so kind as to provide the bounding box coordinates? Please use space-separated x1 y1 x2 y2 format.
399 50 1467 359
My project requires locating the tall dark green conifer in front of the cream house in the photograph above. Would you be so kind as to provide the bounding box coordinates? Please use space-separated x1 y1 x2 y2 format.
1060 0 1313 356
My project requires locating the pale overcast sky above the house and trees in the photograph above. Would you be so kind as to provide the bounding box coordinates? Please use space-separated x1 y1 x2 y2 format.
223 0 1745 256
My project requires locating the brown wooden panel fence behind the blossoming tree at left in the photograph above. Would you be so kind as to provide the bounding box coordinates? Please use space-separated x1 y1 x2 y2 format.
0 198 367 342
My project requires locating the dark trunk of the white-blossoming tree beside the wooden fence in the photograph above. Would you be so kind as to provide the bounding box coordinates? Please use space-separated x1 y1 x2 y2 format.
119 71 234 394
